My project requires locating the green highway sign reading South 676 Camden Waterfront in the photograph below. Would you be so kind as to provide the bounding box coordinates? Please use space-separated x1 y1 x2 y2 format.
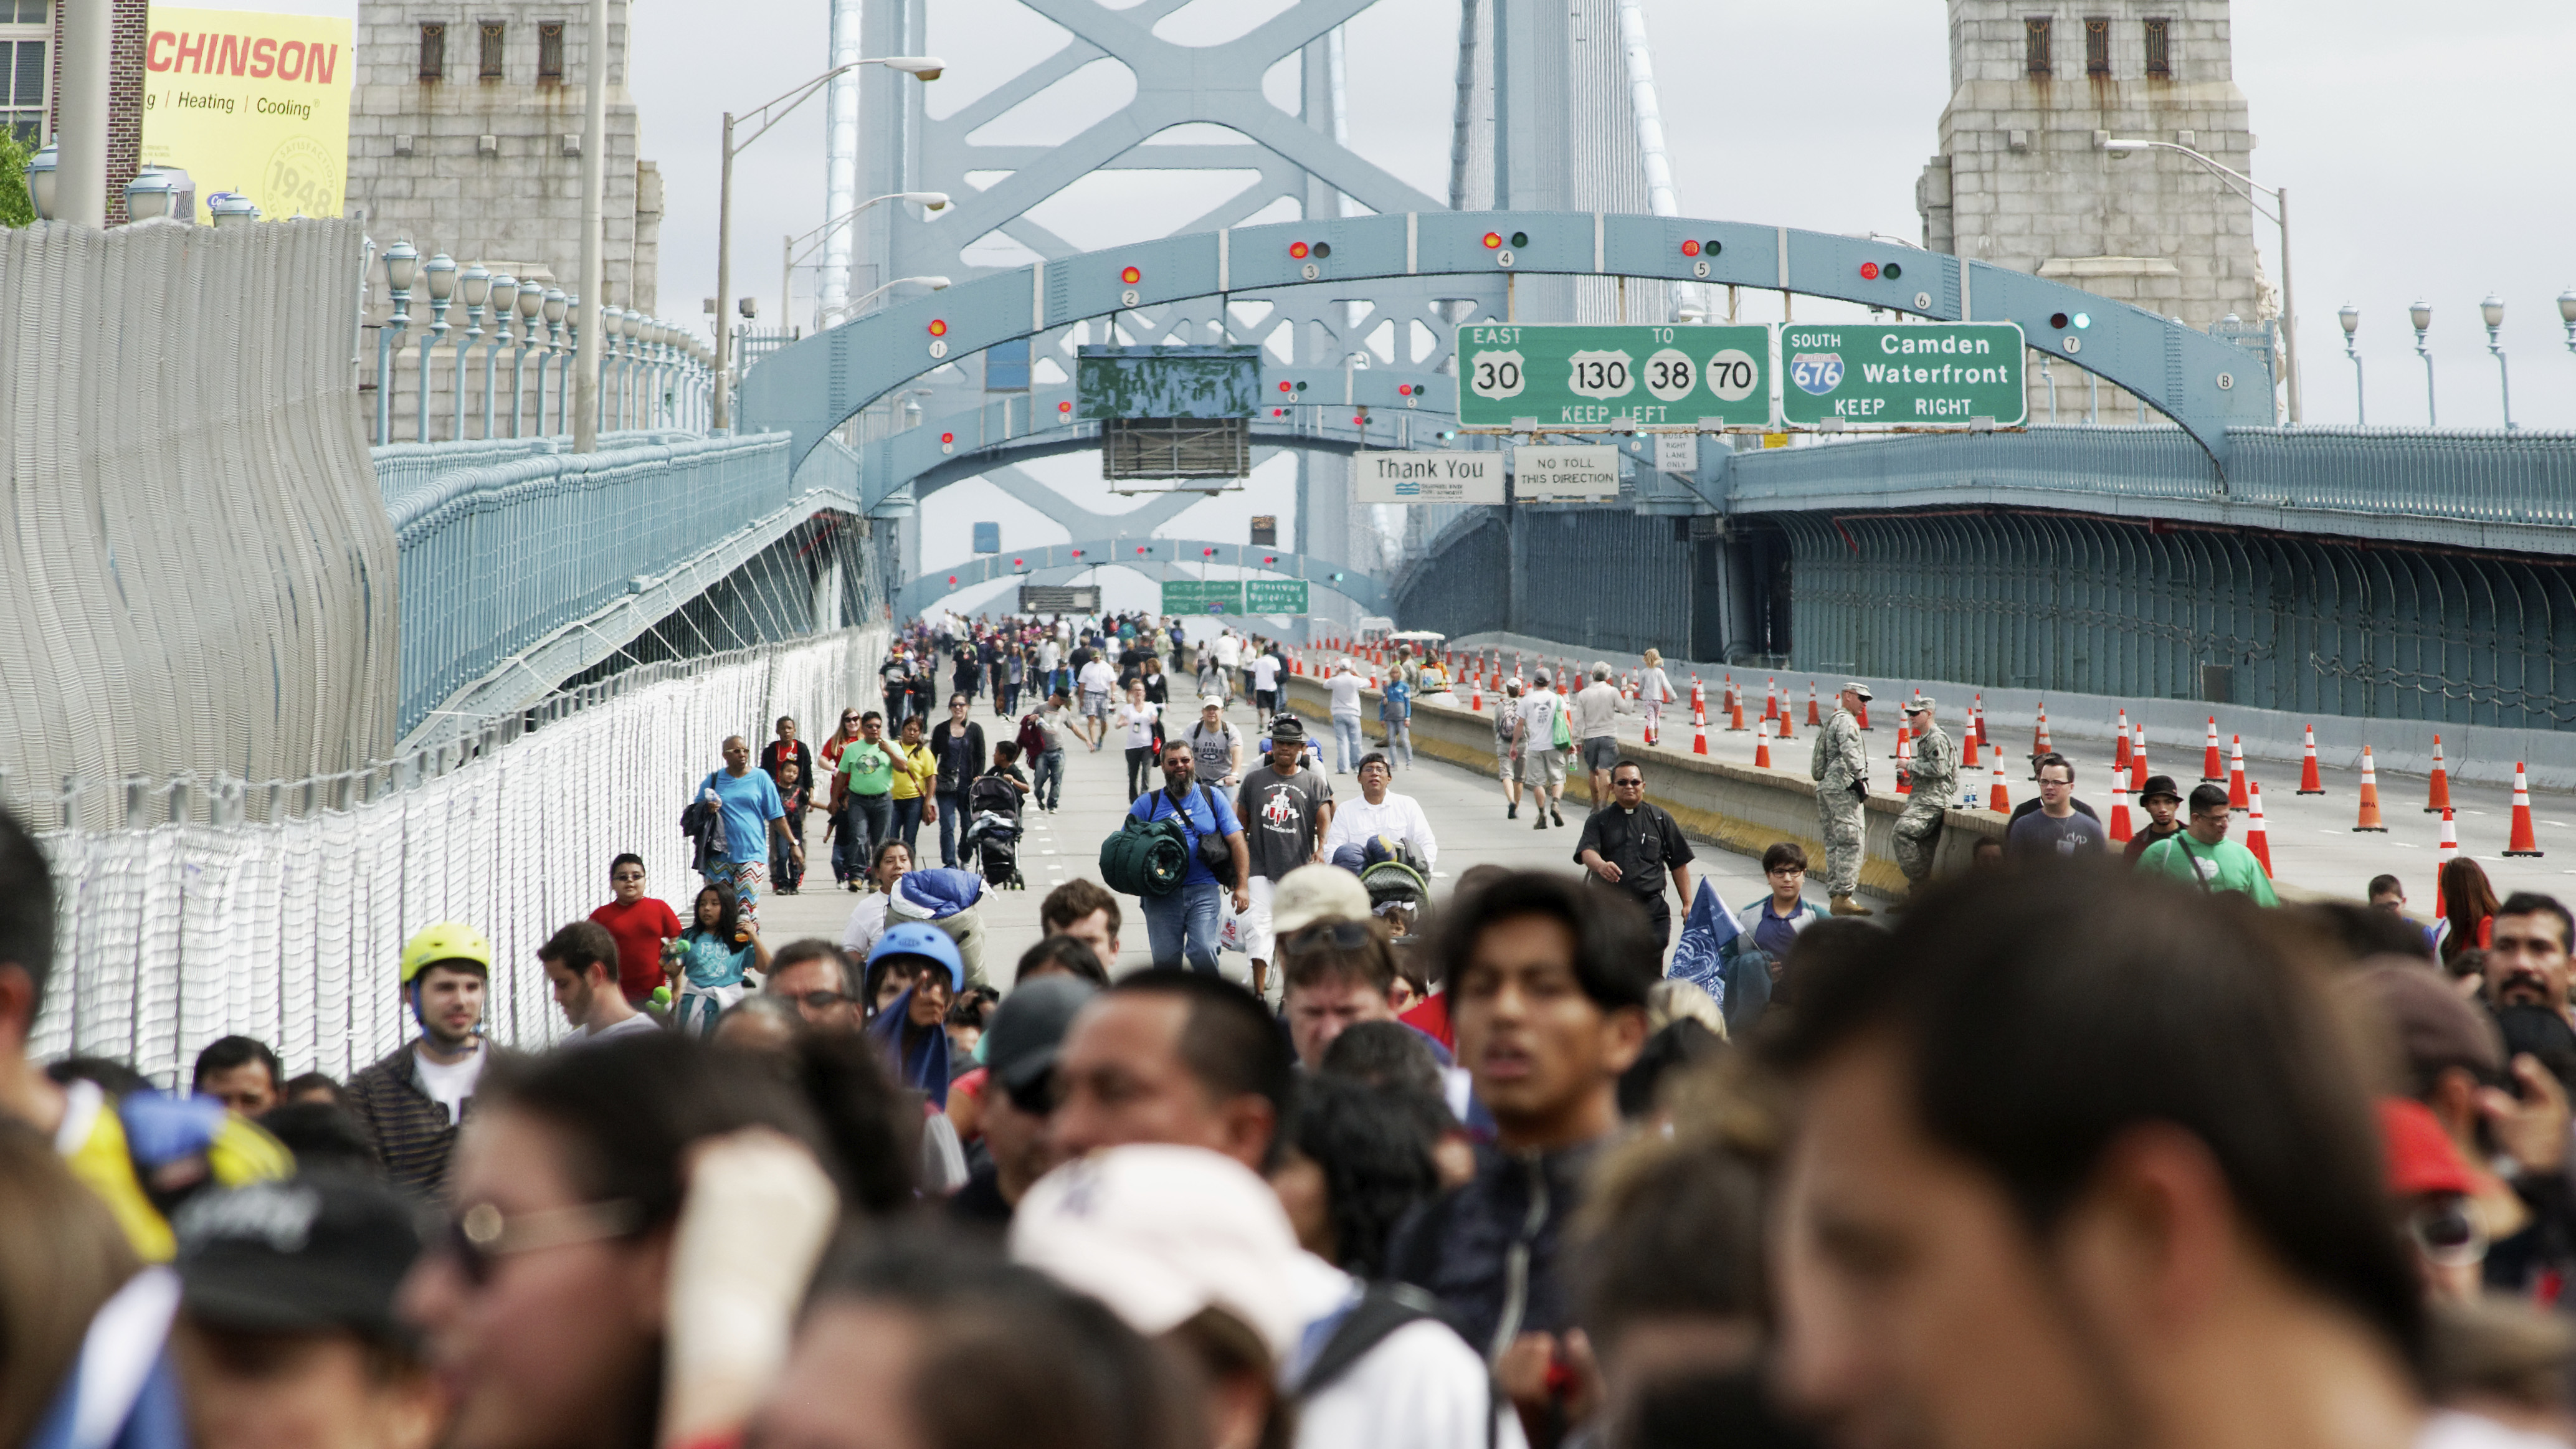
1780 321 2030 427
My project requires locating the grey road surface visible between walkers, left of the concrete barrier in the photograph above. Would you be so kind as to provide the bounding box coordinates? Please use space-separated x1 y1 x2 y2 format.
760 700 1782 999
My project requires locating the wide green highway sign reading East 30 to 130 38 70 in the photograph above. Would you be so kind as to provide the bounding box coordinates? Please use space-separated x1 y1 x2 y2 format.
1458 321 1772 427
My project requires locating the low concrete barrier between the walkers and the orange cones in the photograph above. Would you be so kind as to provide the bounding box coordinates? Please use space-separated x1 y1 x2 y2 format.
1288 674 2007 896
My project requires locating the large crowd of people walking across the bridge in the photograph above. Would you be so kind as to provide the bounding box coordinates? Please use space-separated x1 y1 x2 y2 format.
15 620 2576 1449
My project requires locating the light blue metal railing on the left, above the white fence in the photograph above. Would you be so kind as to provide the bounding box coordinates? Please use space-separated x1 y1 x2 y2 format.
379 435 791 733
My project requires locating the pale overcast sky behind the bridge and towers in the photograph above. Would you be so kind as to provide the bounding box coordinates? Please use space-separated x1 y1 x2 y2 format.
240 0 2576 607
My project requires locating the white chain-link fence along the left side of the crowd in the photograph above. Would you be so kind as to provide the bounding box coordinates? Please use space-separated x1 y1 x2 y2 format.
13 623 886 1083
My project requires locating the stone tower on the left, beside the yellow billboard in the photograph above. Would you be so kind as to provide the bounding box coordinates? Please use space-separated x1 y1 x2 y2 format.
348 0 662 325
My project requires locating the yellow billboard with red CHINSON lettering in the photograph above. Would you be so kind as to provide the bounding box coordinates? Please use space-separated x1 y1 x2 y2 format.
145 5 356 221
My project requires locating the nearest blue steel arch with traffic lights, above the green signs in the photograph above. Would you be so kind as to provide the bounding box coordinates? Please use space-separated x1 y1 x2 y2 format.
742 211 2272 471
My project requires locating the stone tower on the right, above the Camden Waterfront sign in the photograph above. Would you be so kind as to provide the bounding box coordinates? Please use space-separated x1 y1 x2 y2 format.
1914 0 2279 422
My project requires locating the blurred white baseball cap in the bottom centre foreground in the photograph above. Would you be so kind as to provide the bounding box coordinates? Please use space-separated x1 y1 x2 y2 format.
1010 1143 1306 1362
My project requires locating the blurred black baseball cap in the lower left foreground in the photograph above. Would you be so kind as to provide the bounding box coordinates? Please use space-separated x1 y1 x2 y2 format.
173 1174 420 1346
